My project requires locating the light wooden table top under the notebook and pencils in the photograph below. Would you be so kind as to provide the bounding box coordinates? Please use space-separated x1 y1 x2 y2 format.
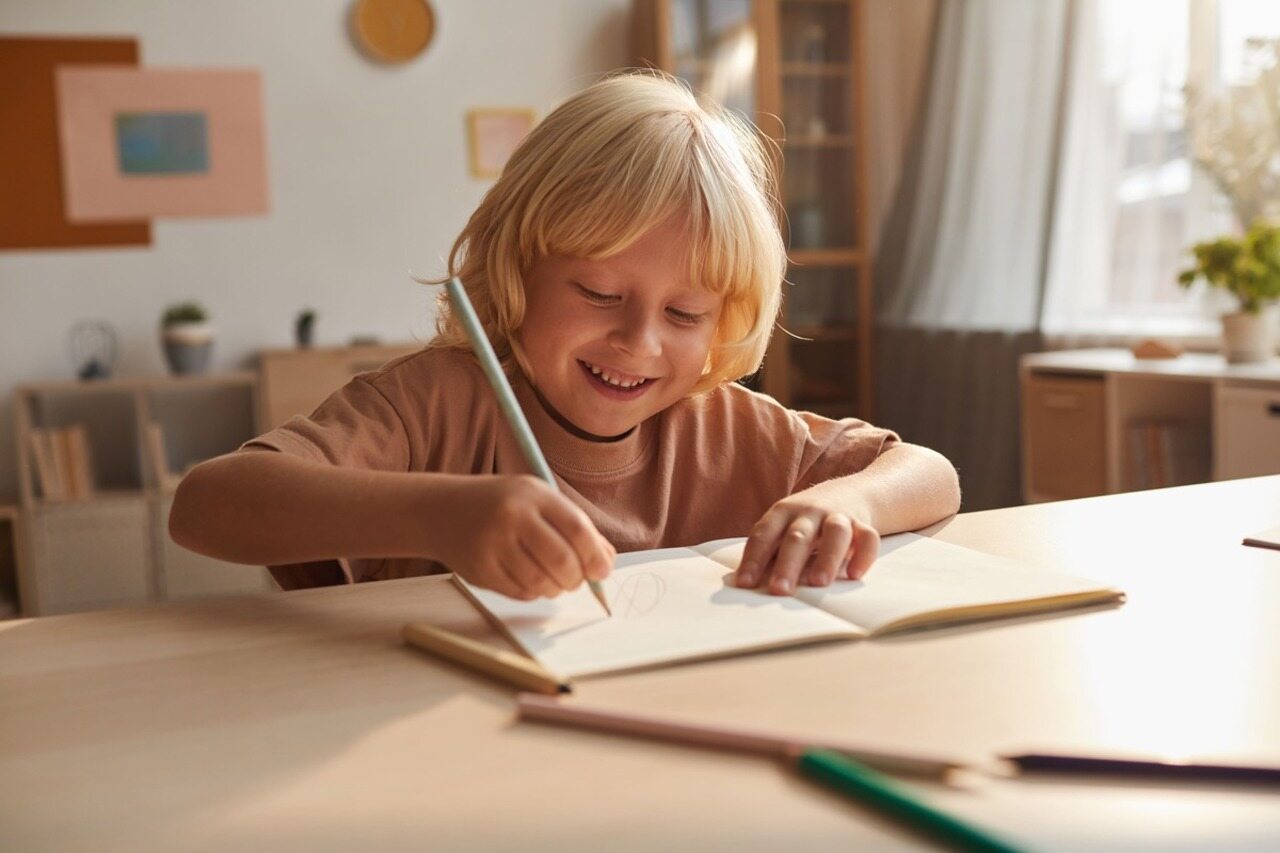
0 476 1280 850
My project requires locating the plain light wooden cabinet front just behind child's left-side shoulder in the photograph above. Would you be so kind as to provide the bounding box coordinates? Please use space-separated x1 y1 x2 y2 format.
259 343 422 433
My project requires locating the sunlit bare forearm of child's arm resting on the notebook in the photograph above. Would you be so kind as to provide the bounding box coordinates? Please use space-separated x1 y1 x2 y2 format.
792 444 960 535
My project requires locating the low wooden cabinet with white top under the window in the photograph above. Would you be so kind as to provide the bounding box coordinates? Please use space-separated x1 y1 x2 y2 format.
1021 350 1280 501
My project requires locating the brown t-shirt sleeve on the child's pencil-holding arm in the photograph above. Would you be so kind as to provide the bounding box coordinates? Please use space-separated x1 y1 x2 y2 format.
241 377 410 471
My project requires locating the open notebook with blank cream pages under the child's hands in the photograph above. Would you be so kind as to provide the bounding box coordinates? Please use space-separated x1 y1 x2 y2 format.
454 533 1124 679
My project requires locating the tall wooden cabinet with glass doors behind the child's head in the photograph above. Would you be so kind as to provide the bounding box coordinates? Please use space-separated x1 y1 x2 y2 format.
635 0 872 418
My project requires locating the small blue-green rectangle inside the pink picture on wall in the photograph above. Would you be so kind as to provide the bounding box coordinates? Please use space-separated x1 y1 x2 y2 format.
115 113 209 174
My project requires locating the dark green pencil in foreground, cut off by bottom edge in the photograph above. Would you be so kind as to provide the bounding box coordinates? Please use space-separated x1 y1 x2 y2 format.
796 749 1019 853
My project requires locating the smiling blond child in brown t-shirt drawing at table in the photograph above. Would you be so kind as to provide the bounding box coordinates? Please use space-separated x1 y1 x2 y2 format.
170 72 960 599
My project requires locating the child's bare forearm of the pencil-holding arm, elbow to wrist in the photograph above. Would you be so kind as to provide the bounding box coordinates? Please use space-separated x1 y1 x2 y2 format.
169 451 465 565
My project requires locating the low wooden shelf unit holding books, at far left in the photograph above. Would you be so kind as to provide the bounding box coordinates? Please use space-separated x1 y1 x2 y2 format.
14 373 273 615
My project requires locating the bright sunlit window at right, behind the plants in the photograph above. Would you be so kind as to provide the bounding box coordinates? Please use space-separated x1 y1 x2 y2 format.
1043 0 1280 334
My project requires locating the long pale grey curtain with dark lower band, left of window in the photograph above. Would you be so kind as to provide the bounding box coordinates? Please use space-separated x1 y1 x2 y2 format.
876 0 1073 510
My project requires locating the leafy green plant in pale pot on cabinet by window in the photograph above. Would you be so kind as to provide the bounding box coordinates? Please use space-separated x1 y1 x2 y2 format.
1178 219 1280 364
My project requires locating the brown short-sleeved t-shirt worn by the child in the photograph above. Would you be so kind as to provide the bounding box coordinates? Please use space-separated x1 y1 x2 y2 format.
242 348 899 588
